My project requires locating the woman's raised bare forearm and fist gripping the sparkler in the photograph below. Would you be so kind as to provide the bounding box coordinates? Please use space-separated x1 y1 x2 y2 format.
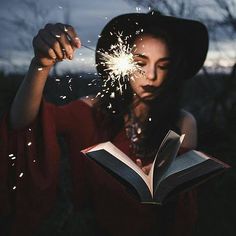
10 23 81 129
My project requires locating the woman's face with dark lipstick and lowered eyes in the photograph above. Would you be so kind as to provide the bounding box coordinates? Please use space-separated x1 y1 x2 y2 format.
130 35 170 100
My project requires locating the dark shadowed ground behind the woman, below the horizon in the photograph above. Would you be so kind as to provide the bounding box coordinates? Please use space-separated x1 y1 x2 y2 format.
0 71 236 236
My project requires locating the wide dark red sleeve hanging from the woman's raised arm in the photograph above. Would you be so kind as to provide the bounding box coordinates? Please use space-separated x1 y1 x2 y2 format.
0 102 59 235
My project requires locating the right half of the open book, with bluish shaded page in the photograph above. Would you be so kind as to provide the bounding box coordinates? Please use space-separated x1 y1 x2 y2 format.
154 150 227 202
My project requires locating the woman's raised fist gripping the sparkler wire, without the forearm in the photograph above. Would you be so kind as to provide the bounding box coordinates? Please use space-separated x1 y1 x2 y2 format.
33 23 81 68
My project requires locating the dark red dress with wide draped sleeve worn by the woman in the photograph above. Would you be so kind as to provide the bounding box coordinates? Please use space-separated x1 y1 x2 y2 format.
0 101 196 236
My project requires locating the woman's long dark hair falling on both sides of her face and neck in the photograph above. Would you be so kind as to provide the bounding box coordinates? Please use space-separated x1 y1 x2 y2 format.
94 24 185 159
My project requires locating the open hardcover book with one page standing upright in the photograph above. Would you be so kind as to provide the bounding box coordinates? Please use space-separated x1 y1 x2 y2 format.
82 130 229 204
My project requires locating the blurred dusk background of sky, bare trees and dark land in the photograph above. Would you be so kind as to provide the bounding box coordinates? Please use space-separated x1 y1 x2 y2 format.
0 0 236 236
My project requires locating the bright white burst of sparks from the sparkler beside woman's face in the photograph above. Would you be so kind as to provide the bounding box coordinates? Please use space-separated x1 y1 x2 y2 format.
98 32 143 94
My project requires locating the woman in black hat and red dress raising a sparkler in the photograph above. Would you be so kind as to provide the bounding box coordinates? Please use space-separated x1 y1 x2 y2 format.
0 12 208 235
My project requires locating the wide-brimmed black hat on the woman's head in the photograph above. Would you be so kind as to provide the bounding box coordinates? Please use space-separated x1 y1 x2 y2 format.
96 11 209 79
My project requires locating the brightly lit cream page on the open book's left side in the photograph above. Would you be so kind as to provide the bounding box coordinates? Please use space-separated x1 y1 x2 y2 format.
88 142 152 193
